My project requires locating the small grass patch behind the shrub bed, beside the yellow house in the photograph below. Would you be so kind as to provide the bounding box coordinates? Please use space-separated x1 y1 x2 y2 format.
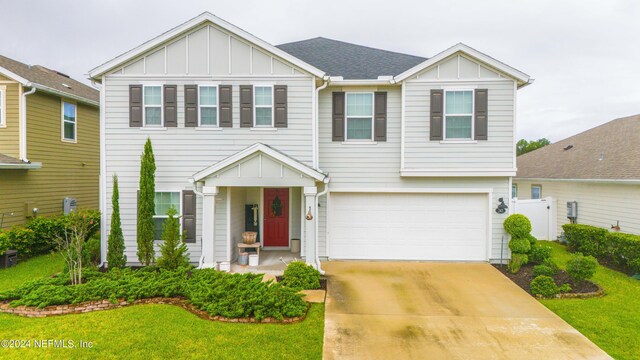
0 253 64 289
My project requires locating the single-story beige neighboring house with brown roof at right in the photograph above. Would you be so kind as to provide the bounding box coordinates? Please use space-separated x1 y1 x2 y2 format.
513 115 640 238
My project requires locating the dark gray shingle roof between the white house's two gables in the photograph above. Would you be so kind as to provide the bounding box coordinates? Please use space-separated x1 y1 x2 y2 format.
277 37 427 79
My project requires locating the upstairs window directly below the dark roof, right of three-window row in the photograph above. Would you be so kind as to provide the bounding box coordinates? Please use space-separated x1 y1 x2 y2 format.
345 93 373 141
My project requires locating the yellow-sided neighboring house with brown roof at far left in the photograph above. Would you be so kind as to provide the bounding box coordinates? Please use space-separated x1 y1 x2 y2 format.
0 56 100 228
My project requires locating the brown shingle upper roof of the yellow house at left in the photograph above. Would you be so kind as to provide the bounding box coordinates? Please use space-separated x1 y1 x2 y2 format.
0 55 100 102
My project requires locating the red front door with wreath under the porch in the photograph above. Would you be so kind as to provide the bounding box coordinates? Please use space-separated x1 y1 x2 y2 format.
263 189 289 246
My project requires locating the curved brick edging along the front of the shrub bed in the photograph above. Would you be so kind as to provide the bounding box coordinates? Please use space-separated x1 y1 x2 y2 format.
0 297 309 324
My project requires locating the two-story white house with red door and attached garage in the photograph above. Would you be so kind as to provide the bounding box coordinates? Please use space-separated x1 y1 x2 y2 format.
90 13 530 266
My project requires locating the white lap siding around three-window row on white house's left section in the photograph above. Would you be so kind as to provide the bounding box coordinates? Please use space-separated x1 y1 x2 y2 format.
104 75 314 262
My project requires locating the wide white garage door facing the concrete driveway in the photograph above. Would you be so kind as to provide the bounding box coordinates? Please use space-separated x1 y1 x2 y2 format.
329 193 488 260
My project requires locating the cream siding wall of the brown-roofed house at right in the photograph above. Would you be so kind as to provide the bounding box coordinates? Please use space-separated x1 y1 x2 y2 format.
513 179 640 235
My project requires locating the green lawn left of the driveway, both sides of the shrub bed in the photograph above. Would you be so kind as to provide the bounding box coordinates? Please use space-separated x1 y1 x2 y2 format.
0 255 324 359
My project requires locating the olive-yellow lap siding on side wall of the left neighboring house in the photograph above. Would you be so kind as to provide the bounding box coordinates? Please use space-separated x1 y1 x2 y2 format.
0 91 100 228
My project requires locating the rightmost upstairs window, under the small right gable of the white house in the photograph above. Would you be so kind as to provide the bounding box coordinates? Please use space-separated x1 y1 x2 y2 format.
444 90 473 140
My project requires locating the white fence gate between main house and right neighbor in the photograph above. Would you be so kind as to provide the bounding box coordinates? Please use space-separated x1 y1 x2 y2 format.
511 197 557 240
